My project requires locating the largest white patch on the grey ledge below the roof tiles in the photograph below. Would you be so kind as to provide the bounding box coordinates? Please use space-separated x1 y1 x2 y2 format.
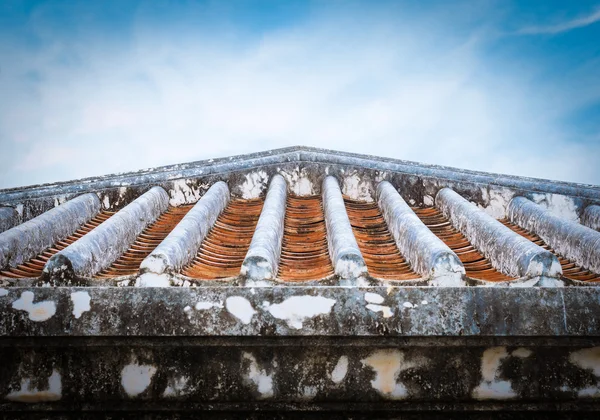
266 295 335 330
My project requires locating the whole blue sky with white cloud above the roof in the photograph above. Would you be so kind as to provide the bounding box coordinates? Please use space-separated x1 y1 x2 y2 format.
0 0 600 188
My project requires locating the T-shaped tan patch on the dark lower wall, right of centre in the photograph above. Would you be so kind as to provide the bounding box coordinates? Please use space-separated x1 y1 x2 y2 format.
361 349 422 399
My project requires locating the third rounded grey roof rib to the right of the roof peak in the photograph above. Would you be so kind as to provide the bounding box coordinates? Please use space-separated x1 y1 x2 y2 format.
435 188 562 285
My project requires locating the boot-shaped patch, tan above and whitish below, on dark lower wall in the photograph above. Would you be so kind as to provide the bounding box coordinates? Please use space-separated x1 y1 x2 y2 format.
472 347 517 400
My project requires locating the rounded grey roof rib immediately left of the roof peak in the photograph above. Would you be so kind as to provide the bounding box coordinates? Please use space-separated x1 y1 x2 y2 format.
241 175 287 281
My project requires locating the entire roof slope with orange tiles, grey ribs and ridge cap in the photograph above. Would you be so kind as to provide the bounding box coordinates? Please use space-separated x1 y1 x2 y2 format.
0 148 600 286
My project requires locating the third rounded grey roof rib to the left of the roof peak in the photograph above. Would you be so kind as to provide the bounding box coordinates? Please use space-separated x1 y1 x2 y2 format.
44 187 169 280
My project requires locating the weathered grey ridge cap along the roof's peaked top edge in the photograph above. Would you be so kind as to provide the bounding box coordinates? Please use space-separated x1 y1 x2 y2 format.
0 146 600 203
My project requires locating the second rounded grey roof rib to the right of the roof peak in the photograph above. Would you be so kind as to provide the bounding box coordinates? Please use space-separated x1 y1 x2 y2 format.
377 181 465 286
